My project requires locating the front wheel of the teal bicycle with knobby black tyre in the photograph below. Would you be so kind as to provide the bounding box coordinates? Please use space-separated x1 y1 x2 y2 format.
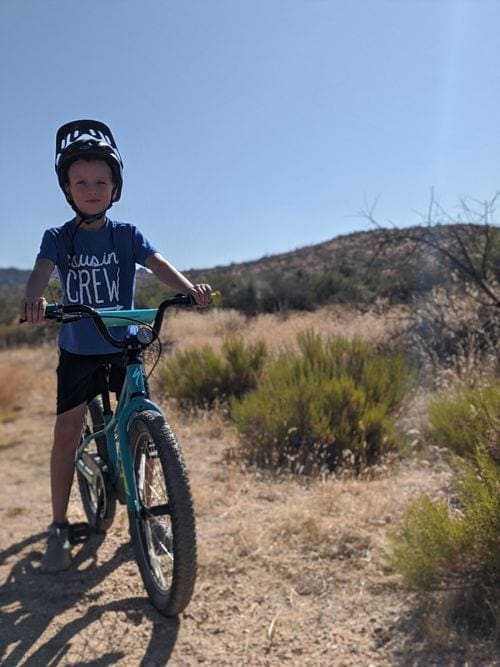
129 411 196 616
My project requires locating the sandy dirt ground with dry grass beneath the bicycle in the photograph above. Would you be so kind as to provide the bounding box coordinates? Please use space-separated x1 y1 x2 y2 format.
0 350 500 667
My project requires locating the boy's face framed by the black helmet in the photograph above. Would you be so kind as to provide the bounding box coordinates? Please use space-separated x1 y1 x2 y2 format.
65 160 115 215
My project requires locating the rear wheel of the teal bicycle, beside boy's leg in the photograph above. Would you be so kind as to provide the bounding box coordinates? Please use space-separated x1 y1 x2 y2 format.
76 397 116 533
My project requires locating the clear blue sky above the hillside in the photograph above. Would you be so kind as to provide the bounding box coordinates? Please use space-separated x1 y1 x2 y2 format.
0 0 500 269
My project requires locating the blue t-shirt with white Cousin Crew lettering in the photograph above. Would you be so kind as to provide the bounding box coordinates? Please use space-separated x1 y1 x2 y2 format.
37 220 157 354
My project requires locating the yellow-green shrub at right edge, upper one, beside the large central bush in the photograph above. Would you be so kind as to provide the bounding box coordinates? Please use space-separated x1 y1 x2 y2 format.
428 380 500 458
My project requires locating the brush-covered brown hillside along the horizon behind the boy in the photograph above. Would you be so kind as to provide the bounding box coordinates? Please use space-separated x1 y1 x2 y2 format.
0 224 500 322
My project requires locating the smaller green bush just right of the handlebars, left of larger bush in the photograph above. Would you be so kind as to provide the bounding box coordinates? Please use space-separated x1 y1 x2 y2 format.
158 336 266 408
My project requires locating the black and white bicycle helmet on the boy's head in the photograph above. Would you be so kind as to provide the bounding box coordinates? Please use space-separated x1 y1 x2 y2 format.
55 120 123 222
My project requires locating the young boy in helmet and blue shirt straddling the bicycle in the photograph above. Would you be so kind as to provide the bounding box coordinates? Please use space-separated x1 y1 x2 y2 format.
21 120 211 572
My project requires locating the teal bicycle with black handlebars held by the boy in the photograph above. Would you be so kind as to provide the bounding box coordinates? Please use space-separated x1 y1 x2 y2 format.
45 294 215 616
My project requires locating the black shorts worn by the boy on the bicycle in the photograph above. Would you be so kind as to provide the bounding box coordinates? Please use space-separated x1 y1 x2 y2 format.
57 349 125 415
